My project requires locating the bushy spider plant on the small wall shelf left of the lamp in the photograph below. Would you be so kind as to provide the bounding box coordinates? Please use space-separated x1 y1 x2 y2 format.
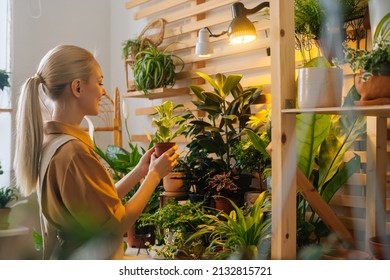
134 45 184 94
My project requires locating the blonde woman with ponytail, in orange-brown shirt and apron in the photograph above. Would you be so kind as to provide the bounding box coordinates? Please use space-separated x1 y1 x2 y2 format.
14 45 178 259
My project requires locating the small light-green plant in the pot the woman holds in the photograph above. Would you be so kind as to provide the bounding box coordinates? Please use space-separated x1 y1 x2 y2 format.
152 100 192 143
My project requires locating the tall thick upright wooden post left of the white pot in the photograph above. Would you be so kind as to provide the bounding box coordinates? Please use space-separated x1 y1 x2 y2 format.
270 0 296 259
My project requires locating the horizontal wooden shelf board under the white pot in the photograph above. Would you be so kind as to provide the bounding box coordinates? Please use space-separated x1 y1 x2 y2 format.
281 105 390 117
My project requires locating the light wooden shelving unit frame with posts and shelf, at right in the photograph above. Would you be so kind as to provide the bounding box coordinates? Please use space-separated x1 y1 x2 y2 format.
270 0 390 259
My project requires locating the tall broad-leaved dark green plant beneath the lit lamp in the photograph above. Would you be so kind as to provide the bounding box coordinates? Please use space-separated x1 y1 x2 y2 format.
187 72 261 186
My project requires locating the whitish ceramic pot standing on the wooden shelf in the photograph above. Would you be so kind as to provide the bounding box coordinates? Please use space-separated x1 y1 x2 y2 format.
297 67 343 108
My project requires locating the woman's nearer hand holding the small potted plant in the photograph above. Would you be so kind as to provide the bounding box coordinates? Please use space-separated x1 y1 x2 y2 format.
149 145 179 182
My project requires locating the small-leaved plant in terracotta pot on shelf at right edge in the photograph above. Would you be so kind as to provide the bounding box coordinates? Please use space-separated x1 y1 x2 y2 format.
343 13 390 105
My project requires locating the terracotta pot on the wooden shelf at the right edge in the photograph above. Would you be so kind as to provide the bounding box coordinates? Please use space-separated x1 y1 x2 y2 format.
355 75 390 105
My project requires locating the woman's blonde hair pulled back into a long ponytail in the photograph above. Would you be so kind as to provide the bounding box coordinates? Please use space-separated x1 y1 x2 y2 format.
14 45 96 196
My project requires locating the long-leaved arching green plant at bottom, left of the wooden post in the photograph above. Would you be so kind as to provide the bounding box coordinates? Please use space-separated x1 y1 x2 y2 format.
186 192 271 259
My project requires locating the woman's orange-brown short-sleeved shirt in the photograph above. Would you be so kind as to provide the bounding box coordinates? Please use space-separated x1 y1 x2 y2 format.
42 121 125 258
